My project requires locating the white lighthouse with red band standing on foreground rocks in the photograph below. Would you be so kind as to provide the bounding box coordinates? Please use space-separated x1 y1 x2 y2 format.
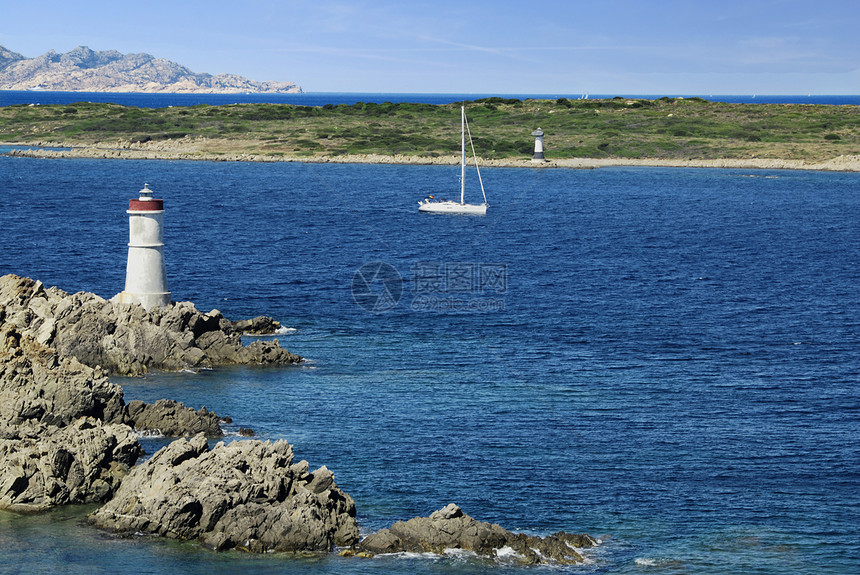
112 184 170 310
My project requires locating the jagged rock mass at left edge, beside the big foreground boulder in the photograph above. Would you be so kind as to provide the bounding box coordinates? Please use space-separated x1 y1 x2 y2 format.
0 417 141 512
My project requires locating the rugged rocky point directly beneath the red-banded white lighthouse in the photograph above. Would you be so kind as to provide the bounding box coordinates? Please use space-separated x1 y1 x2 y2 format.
0 275 302 375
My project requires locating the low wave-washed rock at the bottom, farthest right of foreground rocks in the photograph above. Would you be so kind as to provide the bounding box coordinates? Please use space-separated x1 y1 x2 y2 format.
358 503 597 565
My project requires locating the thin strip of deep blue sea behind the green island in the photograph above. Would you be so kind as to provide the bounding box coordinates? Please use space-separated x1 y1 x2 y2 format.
0 90 860 108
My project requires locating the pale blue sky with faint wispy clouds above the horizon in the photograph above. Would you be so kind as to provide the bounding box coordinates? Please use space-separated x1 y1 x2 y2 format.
0 0 860 95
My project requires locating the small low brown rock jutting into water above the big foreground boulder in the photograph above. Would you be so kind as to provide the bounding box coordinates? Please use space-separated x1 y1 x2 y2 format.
126 399 224 437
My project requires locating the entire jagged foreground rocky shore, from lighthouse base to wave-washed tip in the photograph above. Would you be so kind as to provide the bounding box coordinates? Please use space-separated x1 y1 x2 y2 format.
0 274 597 565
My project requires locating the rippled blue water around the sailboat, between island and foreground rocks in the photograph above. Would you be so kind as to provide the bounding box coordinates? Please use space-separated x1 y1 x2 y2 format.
0 157 860 574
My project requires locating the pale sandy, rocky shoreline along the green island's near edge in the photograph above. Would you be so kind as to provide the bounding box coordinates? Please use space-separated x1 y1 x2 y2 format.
7 138 860 172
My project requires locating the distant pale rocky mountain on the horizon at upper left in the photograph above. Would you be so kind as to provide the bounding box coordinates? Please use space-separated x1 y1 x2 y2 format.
0 46 302 94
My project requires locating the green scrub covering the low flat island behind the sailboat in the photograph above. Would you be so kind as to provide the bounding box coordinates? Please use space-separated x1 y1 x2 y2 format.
0 98 860 161
